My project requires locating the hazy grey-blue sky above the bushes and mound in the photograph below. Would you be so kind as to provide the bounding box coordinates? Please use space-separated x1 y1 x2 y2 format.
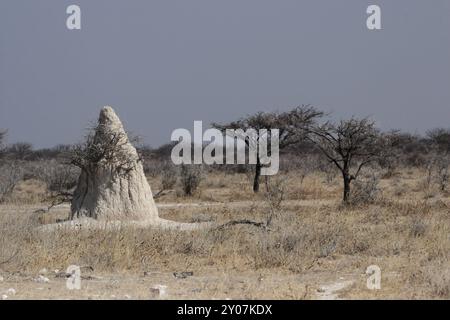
0 0 450 147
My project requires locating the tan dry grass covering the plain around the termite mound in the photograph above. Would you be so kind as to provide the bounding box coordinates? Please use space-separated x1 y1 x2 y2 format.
0 170 450 299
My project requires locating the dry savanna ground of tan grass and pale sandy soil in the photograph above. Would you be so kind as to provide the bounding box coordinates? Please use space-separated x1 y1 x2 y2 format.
0 169 450 299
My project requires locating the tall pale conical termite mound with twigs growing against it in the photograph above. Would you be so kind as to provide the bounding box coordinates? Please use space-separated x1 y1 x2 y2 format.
71 107 158 221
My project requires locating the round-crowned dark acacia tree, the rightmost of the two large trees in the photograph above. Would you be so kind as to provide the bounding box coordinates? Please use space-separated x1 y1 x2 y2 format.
308 117 385 203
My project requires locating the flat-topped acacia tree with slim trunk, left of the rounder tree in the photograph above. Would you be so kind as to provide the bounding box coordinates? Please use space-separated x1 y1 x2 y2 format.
212 105 323 192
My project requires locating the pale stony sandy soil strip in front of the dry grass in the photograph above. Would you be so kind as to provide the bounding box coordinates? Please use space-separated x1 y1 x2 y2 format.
0 270 384 300
